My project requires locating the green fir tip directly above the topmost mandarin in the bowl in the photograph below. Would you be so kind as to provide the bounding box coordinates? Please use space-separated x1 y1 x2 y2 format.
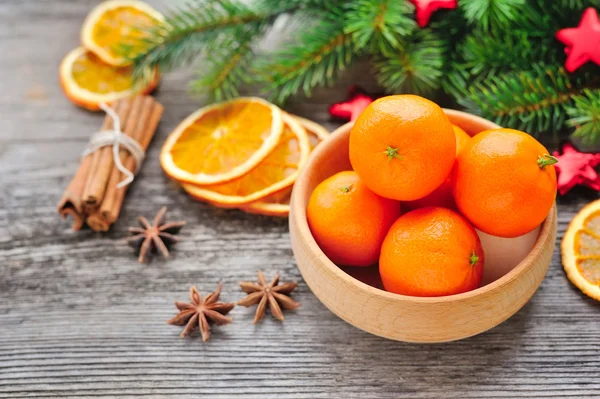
375 29 445 94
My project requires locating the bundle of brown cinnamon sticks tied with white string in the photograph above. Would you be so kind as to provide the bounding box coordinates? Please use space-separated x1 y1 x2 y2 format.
58 95 163 231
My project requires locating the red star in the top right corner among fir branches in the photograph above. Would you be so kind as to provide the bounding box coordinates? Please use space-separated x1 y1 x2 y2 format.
556 7 600 72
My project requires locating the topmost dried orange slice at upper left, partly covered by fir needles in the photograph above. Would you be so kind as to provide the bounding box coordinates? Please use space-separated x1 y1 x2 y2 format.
81 0 165 66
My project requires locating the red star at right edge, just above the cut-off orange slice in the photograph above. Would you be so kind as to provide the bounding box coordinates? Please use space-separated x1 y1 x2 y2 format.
552 143 600 195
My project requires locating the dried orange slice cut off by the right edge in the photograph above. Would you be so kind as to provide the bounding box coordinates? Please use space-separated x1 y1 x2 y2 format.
560 200 600 301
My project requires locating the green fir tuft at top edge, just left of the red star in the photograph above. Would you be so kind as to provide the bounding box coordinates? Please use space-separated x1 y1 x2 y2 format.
344 0 417 53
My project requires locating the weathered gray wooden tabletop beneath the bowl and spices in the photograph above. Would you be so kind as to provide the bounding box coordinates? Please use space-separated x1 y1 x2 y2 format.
0 0 600 399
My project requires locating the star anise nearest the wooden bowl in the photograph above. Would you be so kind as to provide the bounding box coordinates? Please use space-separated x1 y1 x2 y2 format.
238 270 300 324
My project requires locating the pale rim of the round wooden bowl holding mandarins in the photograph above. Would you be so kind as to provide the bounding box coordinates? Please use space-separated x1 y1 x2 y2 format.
290 109 556 304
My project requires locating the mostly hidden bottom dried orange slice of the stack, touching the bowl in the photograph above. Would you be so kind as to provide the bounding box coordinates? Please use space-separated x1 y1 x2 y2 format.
242 115 329 217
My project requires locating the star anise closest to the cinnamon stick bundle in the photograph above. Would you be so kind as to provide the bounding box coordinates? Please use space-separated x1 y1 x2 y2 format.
127 206 186 263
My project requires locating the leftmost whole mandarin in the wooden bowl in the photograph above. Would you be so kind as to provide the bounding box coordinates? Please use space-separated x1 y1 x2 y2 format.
306 171 400 266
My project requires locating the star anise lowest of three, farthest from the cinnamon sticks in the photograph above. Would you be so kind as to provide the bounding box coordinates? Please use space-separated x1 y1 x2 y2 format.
167 283 235 342
